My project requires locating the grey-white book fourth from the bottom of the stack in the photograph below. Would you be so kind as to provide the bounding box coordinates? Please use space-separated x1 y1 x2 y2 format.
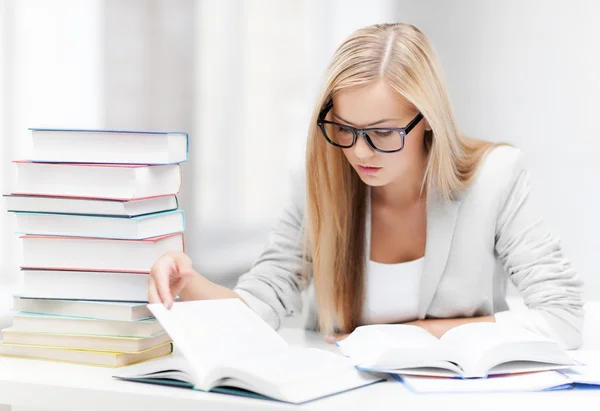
13 296 152 321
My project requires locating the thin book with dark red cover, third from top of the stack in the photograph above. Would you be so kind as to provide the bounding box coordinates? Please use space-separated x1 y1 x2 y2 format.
4 194 178 217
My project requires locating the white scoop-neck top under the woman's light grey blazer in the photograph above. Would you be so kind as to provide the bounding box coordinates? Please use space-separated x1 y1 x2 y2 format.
362 257 425 324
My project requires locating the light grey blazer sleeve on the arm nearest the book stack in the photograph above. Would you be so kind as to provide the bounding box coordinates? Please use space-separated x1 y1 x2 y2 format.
234 172 312 329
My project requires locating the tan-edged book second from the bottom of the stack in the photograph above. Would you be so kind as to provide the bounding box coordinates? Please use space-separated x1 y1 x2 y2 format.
2 327 171 354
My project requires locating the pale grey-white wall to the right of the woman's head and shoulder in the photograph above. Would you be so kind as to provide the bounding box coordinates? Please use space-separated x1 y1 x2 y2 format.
398 0 600 299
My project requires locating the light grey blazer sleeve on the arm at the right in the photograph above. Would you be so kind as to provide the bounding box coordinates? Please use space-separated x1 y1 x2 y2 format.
495 154 584 349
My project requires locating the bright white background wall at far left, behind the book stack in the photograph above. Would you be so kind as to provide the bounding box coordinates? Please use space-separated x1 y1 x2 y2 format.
0 0 102 283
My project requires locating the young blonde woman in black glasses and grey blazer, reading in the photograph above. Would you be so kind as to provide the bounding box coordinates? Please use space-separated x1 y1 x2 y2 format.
149 24 583 348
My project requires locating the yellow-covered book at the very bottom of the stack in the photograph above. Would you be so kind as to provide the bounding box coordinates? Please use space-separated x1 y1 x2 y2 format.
0 342 173 368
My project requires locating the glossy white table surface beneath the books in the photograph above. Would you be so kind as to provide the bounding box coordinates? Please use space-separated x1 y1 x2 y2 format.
0 328 600 411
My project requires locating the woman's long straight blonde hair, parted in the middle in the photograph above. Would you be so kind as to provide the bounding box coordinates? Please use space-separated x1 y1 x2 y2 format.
306 24 495 333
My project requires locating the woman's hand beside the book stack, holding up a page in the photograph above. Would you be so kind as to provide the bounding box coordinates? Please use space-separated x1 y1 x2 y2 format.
148 251 197 308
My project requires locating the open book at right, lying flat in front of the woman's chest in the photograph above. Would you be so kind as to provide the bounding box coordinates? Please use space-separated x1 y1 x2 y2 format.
337 322 575 378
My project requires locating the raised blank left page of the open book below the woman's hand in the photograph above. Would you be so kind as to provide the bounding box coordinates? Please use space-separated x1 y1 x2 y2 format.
148 298 288 389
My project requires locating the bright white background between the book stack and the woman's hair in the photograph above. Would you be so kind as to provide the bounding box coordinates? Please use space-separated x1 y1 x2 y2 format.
191 0 404 284
